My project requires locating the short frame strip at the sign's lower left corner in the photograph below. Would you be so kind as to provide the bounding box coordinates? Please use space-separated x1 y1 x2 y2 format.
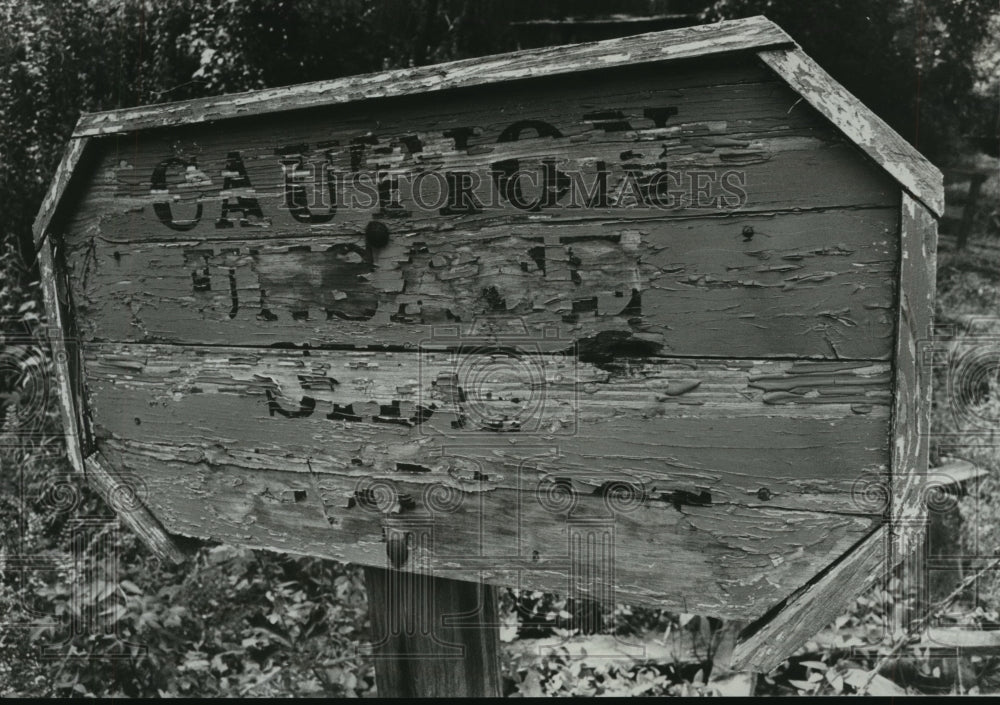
84 452 188 563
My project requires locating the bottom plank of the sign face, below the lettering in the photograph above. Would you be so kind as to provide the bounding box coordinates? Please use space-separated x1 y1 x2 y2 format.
100 438 878 618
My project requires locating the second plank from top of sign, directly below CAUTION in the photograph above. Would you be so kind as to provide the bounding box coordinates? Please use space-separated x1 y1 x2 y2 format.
70 208 899 360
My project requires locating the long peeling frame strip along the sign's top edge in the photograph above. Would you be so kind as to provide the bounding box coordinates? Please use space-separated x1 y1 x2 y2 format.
68 17 791 137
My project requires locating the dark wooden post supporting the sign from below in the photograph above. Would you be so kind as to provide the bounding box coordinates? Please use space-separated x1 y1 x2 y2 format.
365 566 500 698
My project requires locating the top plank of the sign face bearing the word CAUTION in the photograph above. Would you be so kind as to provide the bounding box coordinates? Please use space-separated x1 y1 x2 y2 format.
66 59 899 249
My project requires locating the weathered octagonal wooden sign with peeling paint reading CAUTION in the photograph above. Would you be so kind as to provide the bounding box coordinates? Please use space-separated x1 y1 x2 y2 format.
36 18 942 670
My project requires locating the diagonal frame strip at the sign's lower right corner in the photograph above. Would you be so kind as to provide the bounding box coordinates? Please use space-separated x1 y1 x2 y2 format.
732 526 892 673
